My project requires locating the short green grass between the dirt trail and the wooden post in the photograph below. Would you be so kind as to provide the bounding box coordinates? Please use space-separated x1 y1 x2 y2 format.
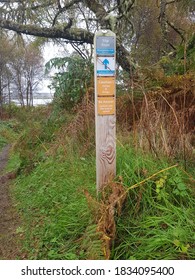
15 152 95 259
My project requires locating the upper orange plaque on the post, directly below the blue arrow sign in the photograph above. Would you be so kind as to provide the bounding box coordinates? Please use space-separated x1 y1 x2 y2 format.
97 77 115 96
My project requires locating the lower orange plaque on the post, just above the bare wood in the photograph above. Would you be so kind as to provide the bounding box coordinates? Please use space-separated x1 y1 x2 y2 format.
97 97 115 116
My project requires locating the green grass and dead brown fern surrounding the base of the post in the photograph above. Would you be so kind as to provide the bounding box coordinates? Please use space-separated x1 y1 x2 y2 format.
12 140 195 260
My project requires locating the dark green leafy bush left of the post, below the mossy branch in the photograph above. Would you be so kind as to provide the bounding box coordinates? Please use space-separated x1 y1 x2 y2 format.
45 55 93 110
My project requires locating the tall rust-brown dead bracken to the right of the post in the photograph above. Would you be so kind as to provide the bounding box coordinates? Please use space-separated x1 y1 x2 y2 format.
117 73 195 170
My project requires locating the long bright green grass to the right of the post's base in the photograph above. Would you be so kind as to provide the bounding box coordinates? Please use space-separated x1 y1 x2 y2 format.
112 146 195 259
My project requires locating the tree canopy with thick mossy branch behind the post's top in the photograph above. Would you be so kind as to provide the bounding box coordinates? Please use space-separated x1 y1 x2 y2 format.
0 0 195 72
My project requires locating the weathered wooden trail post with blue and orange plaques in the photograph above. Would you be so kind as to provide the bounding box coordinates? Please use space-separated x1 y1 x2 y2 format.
94 30 116 191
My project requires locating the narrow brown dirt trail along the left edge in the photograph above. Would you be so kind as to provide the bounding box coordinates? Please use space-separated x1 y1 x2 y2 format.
0 145 19 260
